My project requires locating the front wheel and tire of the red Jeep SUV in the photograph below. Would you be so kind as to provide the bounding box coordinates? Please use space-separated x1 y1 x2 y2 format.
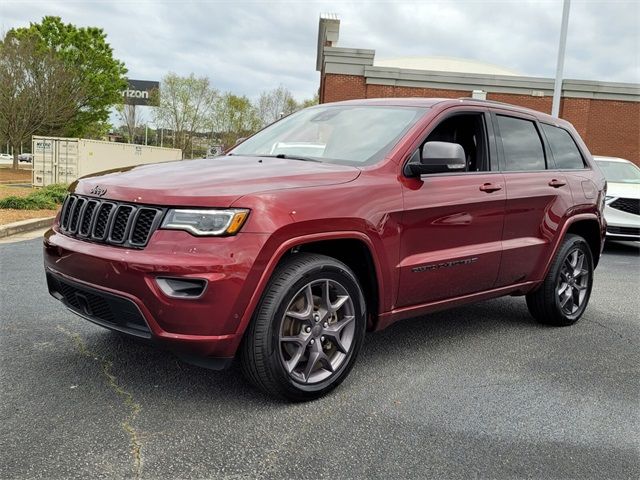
240 253 366 401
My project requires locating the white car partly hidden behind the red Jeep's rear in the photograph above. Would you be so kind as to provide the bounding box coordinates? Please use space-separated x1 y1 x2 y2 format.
593 156 640 240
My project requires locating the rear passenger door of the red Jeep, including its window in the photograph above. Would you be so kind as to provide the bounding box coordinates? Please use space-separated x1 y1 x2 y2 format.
492 110 573 287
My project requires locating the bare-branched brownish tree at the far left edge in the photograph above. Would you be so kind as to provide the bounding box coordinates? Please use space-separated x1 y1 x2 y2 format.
0 32 89 169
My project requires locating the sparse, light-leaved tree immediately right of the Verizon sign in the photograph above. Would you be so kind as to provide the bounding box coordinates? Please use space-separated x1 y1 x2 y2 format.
155 73 218 155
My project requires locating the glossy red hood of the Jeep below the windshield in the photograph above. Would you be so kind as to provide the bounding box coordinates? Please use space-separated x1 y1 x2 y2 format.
72 156 360 207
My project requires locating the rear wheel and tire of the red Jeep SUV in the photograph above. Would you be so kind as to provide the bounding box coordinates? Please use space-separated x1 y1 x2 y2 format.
527 234 593 327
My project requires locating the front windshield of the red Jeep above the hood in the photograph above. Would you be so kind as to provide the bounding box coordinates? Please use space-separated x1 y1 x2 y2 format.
229 105 426 165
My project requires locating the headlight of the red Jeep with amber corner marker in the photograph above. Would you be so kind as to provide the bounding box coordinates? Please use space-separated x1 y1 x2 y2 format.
160 208 249 236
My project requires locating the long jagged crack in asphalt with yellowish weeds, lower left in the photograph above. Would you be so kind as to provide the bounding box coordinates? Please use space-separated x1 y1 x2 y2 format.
57 325 142 478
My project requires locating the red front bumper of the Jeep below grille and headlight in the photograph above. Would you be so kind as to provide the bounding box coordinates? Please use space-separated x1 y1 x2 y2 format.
44 227 266 366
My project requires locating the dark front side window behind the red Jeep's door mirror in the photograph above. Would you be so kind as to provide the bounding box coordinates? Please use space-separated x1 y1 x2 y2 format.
421 113 489 172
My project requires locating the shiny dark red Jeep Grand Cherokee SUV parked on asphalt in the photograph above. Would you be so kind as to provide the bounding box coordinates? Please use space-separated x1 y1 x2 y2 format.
44 99 605 400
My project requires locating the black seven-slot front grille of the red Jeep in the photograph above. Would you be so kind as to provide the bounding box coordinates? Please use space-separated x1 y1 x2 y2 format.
60 194 165 248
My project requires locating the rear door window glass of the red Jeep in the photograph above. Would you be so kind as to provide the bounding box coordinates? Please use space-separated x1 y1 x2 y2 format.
497 115 546 171
